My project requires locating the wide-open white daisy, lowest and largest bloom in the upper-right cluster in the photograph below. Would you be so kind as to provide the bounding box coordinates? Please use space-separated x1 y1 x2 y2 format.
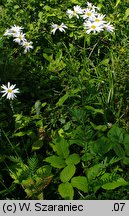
84 21 103 34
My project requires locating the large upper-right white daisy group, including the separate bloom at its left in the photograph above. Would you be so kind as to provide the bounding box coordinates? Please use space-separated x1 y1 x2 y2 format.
51 2 114 34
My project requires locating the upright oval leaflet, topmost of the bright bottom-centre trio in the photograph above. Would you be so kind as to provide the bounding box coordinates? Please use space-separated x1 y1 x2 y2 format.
60 165 76 182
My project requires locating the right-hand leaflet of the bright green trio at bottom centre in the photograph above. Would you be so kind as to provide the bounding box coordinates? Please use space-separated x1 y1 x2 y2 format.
71 176 88 193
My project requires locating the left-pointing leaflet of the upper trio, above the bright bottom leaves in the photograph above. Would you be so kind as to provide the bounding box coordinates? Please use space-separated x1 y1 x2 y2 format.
45 155 66 169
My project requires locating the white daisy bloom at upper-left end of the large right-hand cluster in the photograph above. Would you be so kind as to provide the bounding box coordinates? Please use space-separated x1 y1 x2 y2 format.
66 5 83 19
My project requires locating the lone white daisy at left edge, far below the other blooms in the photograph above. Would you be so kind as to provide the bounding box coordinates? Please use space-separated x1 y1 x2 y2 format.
1 82 20 100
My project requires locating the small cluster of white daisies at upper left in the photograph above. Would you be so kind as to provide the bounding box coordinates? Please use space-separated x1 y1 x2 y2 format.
4 25 33 53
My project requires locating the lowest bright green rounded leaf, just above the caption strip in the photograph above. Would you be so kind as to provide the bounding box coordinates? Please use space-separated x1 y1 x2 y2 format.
58 182 74 200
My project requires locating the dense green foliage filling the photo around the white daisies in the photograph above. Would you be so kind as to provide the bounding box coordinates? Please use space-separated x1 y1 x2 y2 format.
0 0 129 200
